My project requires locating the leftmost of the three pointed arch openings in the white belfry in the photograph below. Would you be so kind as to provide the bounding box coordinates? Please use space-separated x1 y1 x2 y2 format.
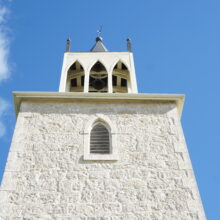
66 61 85 92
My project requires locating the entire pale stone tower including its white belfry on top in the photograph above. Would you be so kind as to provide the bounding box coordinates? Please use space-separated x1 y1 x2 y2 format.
0 36 205 220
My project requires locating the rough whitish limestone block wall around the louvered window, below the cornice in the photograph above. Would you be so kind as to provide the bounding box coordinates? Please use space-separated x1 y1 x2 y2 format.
0 101 205 220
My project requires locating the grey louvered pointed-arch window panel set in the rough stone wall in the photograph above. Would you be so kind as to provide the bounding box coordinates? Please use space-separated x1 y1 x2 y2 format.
90 123 110 154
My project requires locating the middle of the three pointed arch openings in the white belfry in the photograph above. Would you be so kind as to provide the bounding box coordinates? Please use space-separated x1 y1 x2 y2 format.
89 61 108 92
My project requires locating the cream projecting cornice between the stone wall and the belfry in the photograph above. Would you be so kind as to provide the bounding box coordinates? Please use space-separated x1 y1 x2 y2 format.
13 92 185 118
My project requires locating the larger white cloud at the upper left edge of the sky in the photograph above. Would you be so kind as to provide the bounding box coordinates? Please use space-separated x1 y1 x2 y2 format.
0 5 10 82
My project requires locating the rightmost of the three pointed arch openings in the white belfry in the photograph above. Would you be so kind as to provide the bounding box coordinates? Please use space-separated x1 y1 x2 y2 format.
112 61 130 93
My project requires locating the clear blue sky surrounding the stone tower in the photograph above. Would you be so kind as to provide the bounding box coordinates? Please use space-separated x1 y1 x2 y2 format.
0 0 220 220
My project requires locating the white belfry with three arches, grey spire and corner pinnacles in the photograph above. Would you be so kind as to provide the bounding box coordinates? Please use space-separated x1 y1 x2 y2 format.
59 36 137 93
